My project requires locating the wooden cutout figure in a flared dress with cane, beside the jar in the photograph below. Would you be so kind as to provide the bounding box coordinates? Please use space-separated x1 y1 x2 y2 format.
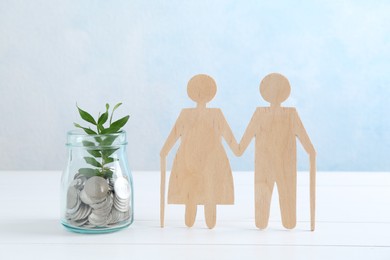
160 74 238 228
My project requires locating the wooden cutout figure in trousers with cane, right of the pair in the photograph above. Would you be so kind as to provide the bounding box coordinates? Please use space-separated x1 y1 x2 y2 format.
239 73 316 230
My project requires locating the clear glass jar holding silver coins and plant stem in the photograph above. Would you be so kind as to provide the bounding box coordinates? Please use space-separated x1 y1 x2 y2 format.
61 131 133 233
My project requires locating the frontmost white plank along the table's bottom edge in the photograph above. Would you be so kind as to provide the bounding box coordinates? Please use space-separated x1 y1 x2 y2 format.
0 243 390 260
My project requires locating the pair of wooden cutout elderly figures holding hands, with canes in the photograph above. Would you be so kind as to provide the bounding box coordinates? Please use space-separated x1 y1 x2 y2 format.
160 73 316 231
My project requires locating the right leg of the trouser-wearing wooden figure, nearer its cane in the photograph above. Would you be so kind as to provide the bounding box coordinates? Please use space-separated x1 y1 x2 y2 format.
276 171 297 229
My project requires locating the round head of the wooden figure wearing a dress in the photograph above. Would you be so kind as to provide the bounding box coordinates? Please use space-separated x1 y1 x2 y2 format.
187 74 217 105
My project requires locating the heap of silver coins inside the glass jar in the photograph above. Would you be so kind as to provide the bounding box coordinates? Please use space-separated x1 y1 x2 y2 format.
65 174 131 228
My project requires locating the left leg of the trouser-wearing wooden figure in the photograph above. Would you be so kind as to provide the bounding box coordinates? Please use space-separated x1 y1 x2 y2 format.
255 170 274 229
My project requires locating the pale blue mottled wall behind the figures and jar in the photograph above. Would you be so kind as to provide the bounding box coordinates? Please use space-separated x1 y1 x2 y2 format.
0 0 390 171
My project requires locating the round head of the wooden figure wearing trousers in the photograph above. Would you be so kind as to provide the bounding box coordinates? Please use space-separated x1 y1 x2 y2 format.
260 73 291 106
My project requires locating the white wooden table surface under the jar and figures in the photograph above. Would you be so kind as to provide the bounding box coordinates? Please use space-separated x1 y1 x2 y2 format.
0 171 390 260
